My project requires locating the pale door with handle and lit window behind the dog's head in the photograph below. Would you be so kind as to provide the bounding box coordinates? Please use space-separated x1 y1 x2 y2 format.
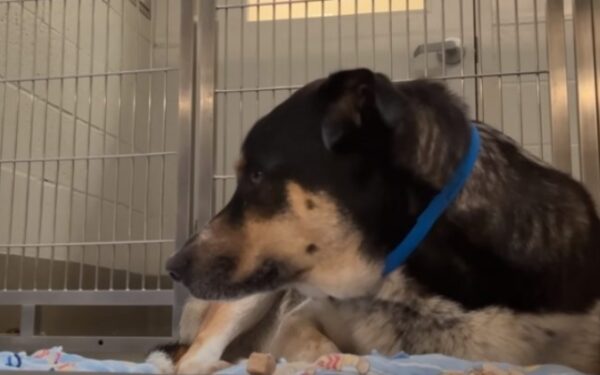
212 0 484 213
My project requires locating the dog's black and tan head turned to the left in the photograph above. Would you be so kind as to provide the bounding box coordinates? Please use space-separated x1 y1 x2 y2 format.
167 69 414 299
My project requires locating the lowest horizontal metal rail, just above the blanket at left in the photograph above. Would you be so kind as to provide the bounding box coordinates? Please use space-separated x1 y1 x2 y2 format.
0 335 174 354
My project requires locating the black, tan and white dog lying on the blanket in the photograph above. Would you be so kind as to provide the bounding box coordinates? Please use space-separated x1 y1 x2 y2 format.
151 69 600 374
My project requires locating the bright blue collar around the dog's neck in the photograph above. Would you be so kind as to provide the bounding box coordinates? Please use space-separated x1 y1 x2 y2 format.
383 124 480 276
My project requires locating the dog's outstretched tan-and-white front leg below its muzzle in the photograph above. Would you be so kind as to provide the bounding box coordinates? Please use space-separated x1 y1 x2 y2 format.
177 293 277 374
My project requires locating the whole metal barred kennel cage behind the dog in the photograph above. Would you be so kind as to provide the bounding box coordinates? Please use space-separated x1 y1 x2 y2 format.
0 0 600 358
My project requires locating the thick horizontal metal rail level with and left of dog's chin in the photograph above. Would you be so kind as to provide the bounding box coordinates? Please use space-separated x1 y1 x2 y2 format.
0 289 173 306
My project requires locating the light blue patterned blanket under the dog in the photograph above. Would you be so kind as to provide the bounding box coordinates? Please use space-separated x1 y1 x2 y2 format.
0 347 580 375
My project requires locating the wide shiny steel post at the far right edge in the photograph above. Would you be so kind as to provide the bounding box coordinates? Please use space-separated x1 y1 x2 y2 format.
573 0 600 204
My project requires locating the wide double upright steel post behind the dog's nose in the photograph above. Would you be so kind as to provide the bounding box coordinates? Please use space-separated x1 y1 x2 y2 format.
172 0 216 335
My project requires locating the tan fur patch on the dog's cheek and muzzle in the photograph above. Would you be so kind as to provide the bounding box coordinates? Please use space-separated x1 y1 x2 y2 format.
233 182 380 297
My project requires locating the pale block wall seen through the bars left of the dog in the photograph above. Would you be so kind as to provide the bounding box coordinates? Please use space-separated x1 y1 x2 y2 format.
0 0 179 288
